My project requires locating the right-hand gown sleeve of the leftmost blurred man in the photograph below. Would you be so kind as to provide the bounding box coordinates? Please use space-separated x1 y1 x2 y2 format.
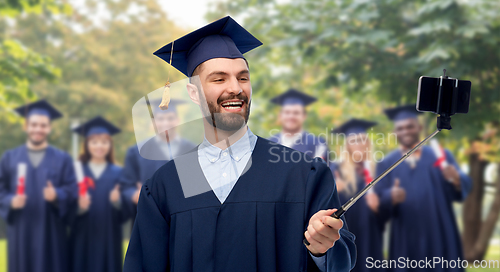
56 154 78 217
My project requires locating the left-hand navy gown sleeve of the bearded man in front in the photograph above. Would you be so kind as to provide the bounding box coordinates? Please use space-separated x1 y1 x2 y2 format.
123 177 170 272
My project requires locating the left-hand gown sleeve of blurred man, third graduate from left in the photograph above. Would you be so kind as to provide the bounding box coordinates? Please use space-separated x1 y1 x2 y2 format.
119 146 141 217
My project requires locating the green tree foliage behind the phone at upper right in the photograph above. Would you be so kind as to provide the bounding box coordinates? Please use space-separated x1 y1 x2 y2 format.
210 0 500 142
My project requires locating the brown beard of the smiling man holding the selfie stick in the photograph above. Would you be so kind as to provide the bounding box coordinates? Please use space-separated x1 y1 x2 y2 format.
200 93 252 131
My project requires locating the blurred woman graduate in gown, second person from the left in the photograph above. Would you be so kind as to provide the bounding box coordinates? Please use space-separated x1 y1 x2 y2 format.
70 117 126 272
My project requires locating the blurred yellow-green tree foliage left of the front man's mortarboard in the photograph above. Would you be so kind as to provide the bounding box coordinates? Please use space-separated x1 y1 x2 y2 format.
3 0 185 160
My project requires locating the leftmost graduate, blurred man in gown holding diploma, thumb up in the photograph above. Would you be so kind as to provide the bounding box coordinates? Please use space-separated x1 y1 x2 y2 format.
0 100 77 272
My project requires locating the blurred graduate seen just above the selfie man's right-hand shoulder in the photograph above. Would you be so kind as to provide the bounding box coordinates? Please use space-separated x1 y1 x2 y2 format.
269 89 328 160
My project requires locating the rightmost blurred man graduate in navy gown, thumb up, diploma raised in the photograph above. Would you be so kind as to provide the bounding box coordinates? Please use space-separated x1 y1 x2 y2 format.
375 105 472 271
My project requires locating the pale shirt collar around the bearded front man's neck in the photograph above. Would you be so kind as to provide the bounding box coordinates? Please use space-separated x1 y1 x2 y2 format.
200 128 257 163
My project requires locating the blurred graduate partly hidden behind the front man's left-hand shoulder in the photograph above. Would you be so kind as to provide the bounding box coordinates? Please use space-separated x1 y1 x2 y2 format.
120 99 195 228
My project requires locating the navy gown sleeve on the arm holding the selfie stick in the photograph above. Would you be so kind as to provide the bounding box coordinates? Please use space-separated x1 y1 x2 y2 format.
304 158 356 272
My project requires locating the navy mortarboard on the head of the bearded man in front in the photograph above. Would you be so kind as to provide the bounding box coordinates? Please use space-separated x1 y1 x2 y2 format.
153 16 262 77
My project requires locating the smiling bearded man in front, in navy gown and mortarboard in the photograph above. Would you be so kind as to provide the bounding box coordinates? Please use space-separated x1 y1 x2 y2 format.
124 17 356 272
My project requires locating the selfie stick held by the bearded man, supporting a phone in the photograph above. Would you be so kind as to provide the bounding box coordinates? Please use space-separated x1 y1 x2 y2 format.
303 69 458 246
